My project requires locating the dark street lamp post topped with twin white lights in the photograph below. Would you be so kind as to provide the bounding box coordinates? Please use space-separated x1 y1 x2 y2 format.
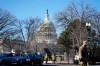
86 22 91 66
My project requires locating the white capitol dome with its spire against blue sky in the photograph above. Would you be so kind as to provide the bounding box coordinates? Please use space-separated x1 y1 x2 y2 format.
37 10 57 44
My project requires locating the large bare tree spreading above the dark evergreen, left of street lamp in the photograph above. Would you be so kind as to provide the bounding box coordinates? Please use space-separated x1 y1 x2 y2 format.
55 2 95 46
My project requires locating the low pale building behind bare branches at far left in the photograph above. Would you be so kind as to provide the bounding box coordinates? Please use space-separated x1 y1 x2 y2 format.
0 39 25 53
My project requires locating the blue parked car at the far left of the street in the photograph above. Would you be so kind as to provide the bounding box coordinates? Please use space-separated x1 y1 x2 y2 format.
0 53 31 64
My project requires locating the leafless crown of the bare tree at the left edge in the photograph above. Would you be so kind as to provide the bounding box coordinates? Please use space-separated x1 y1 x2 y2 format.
0 9 19 44
